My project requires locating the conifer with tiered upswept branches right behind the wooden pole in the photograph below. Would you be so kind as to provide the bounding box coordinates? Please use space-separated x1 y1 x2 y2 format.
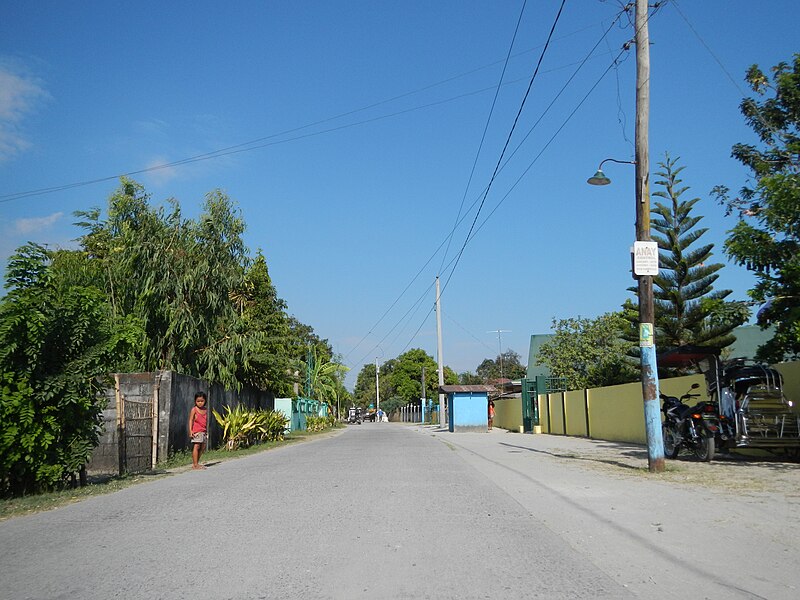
648 156 741 348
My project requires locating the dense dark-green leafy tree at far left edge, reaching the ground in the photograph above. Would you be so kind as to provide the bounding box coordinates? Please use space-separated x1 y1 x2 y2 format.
0 244 138 495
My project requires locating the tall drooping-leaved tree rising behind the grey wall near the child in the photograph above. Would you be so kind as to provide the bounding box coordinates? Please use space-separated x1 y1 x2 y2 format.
76 178 261 387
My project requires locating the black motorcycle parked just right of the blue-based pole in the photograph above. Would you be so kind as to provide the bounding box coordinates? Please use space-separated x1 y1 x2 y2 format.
660 383 720 462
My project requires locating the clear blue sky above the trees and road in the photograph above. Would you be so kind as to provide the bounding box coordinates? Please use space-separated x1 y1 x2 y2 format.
0 0 800 385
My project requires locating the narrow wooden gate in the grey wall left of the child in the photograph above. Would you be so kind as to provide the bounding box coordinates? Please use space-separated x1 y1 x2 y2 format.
116 380 158 474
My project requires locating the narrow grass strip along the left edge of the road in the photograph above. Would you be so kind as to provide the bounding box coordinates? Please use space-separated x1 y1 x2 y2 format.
0 426 341 521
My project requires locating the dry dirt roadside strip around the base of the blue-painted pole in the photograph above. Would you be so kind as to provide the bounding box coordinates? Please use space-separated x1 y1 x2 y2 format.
551 441 800 505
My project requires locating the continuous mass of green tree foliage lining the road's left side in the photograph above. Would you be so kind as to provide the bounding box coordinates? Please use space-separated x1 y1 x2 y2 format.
0 178 332 493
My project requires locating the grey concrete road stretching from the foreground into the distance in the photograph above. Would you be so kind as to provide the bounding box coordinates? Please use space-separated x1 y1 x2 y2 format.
0 423 800 600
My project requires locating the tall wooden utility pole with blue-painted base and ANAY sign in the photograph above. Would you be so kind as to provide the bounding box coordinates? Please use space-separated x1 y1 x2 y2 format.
634 0 664 473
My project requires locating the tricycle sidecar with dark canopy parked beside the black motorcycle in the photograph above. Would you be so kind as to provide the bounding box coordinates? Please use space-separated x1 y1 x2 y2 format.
659 346 800 456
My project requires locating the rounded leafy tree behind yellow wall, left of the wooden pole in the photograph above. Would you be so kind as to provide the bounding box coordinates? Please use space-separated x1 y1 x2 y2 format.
536 313 638 390
